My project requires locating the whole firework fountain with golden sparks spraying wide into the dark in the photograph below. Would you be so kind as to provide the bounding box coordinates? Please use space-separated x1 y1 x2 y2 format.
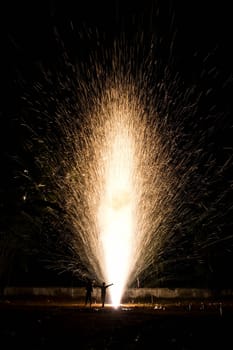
18 21 233 305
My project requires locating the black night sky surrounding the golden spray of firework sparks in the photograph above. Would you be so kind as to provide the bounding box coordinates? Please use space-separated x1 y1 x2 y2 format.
0 0 233 288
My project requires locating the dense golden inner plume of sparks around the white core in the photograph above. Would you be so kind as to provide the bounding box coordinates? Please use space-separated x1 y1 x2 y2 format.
61 84 176 305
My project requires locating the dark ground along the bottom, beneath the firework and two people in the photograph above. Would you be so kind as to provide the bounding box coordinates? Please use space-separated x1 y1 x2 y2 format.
0 299 233 350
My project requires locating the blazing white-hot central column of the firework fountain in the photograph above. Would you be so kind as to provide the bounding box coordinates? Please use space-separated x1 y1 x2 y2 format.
98 110 136 305
